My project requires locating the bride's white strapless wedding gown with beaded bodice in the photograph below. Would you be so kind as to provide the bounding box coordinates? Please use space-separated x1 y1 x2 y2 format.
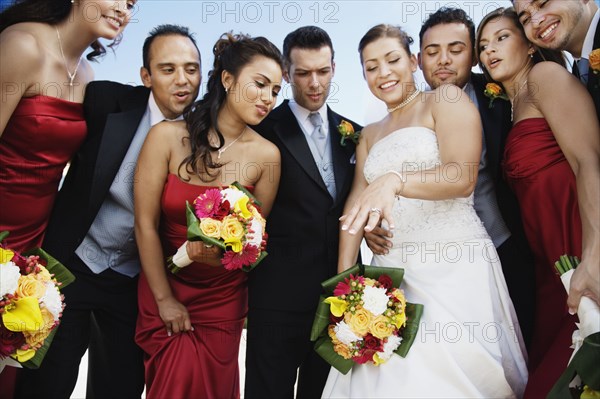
323 127 527 398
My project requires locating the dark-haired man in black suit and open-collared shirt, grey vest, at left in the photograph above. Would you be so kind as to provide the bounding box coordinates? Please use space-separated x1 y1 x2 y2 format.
18 25 200 398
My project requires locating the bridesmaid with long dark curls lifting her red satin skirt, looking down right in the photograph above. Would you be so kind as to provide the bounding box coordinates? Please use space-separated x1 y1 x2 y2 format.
134 34 282 398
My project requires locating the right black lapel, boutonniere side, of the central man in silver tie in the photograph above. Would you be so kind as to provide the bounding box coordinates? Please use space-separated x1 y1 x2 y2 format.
327 106 355 205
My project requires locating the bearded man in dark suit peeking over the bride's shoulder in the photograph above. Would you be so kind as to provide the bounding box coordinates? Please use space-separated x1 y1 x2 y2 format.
366 7 535 350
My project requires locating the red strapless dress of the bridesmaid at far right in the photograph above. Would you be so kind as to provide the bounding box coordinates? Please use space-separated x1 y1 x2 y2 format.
504 118 582 398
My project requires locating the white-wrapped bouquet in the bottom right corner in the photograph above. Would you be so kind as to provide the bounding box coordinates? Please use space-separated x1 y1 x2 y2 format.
548 255 600 399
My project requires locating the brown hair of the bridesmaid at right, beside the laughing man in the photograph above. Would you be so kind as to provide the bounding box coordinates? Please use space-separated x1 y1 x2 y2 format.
475 7 567 83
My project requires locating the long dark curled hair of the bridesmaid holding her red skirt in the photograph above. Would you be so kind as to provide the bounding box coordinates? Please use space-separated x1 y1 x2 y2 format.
179 32 283 181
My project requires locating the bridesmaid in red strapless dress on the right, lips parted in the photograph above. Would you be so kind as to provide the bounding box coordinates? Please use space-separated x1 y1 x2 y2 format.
477 8 600 398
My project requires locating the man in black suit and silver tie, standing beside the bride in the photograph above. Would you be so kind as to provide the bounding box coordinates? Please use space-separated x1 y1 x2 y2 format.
245 26 360 399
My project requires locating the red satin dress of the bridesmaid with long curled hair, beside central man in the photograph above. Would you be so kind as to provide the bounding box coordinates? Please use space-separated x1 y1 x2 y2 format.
135 174 248 399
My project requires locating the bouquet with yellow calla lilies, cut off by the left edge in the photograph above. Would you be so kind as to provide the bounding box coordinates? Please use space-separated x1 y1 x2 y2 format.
0 232 75 369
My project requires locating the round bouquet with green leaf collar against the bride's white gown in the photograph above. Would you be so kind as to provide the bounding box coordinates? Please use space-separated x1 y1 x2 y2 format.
311 264 423 374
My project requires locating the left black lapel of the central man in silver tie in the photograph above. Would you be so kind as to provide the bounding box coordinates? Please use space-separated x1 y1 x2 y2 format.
274 101 327 192
